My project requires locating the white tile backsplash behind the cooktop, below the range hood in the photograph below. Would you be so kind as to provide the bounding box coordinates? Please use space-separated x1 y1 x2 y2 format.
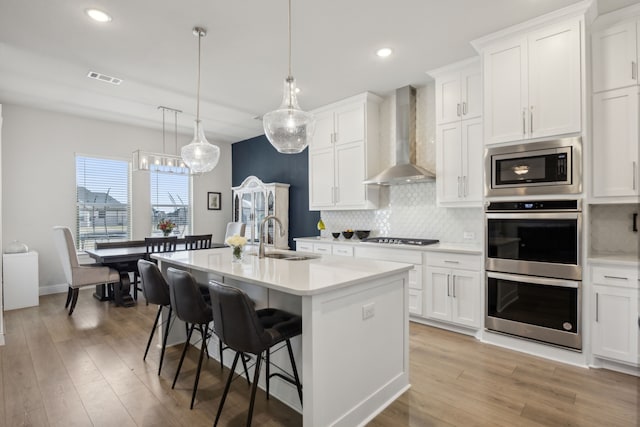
321 182 484 243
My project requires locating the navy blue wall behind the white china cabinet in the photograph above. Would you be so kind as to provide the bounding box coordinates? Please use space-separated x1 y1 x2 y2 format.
231 135 320 249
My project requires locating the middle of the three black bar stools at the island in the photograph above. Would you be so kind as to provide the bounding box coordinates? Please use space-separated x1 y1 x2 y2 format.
167 267 249 409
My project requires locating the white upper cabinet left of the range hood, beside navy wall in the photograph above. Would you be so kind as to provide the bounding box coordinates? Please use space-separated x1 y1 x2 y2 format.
309 93 381 210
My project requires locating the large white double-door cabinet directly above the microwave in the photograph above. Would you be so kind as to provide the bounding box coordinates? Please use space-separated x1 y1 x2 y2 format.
482 19 582 144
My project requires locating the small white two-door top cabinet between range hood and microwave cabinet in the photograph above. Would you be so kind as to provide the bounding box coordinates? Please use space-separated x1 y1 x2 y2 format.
436 59 482 125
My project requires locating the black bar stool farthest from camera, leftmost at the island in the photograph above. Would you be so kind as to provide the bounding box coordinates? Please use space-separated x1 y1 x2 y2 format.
138 259 173 375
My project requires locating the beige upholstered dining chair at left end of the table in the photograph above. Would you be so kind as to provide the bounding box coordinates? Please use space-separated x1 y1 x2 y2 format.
53 226 120 316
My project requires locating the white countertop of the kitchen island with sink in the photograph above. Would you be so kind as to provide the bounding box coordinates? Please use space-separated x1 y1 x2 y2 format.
152 248 413 296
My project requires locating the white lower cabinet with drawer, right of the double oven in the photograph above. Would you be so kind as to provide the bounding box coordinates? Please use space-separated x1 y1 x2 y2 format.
591 266 640 366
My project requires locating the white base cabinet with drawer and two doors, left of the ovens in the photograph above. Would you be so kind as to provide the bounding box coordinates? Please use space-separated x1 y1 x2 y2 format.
425 253 482 328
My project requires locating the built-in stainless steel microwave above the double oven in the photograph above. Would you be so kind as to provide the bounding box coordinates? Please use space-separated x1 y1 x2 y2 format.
485 137 582 197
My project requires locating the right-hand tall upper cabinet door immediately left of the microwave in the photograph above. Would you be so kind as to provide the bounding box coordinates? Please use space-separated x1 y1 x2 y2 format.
461 118 484 206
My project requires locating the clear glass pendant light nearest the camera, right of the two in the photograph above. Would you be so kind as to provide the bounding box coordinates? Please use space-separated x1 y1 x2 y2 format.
262 0 316 154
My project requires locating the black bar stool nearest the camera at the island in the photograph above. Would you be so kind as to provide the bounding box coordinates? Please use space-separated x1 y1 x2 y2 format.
209 280 302 426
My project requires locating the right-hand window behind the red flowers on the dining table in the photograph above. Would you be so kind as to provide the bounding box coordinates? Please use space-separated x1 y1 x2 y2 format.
149 165 191 236
